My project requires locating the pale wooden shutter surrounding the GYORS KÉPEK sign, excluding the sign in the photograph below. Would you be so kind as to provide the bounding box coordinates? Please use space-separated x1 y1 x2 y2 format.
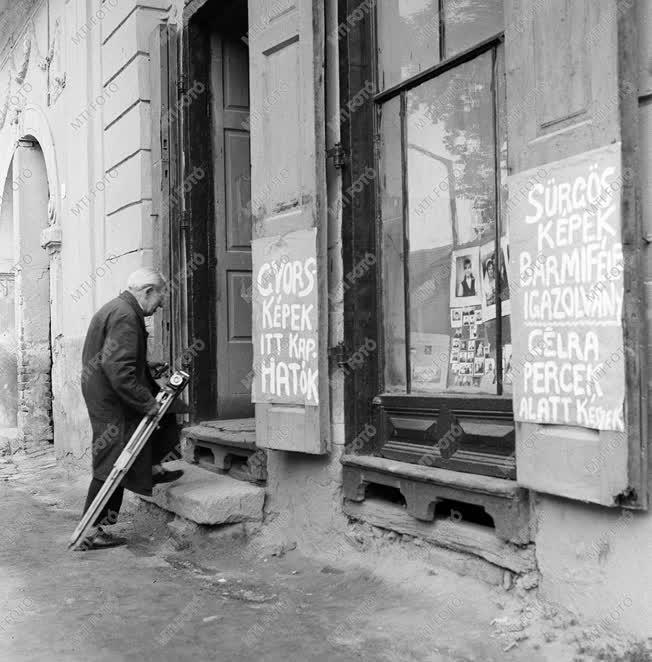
249 0 330 454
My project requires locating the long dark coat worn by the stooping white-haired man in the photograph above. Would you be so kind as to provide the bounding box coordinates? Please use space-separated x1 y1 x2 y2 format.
81 292 178 496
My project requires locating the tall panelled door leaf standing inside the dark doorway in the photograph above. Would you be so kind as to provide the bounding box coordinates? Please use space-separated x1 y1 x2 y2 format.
211 34 254 418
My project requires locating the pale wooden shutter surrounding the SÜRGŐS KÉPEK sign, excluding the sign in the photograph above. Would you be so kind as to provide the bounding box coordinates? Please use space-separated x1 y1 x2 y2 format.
505 0 647 508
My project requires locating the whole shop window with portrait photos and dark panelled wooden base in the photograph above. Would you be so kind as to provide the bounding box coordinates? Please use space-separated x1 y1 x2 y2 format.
366 0 515 478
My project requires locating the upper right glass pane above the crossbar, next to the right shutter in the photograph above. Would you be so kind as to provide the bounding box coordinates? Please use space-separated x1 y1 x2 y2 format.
444 0 503 57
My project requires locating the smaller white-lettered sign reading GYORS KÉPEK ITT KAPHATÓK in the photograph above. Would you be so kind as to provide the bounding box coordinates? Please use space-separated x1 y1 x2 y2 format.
252 229 319 406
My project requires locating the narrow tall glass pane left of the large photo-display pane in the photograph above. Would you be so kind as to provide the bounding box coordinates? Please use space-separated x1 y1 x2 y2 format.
378 97 406 392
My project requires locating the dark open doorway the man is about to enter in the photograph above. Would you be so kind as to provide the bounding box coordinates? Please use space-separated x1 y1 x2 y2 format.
184 0 254 420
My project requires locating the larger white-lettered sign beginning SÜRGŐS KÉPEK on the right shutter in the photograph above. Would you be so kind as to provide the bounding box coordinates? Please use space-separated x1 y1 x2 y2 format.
508 144 625 431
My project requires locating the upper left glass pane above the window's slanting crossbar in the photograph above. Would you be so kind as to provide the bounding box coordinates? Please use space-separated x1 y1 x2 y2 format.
376 0 439 90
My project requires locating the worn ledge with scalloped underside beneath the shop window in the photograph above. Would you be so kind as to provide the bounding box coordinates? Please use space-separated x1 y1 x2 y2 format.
341 455 531 545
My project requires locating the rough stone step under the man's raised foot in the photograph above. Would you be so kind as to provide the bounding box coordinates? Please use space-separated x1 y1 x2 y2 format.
141 460 265 525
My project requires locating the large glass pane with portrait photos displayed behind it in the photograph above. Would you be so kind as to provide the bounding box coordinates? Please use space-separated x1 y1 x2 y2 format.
407 53 497 393
